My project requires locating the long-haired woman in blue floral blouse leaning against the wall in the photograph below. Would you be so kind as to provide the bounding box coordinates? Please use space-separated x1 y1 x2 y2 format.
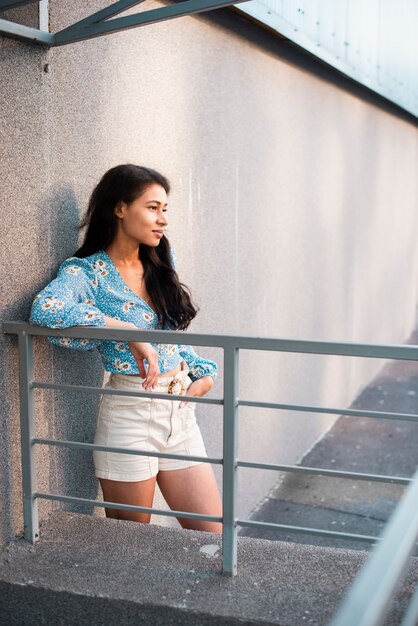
29 164 222 533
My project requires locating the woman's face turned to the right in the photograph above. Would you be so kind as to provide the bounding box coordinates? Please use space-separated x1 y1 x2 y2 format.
115 183 168 246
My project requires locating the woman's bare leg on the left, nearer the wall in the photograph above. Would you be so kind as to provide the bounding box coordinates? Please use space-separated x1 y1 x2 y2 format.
99 476 157 524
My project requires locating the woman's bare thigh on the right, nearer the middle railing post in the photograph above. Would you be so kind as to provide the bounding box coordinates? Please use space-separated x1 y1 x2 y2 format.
157 463 222 533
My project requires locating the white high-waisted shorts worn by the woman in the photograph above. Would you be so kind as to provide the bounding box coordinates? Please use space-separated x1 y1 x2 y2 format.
93 367 208 481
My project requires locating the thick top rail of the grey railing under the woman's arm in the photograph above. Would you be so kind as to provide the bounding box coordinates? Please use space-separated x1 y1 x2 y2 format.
2 321 418 361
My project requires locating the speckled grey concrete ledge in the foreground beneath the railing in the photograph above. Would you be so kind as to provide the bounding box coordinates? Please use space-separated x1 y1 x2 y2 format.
0 511 418 626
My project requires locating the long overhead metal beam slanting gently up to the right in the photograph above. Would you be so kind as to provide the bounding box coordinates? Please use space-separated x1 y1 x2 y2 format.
54 0 248 46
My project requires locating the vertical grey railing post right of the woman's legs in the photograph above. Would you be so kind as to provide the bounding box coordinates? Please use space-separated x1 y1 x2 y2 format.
222 345 239 576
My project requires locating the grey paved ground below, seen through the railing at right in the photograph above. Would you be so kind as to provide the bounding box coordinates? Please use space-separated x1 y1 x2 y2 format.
239 331 418 550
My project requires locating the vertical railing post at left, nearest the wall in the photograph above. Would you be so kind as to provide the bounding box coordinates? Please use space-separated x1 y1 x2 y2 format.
19 331 39 543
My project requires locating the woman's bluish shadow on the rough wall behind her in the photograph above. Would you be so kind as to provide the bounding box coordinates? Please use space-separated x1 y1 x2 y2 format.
34 186 104 519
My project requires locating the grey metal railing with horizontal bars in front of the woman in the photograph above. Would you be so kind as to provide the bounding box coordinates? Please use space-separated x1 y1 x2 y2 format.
3 321 418 575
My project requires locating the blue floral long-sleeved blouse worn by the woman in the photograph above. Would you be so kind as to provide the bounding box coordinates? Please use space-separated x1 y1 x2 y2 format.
29 248 218 381
